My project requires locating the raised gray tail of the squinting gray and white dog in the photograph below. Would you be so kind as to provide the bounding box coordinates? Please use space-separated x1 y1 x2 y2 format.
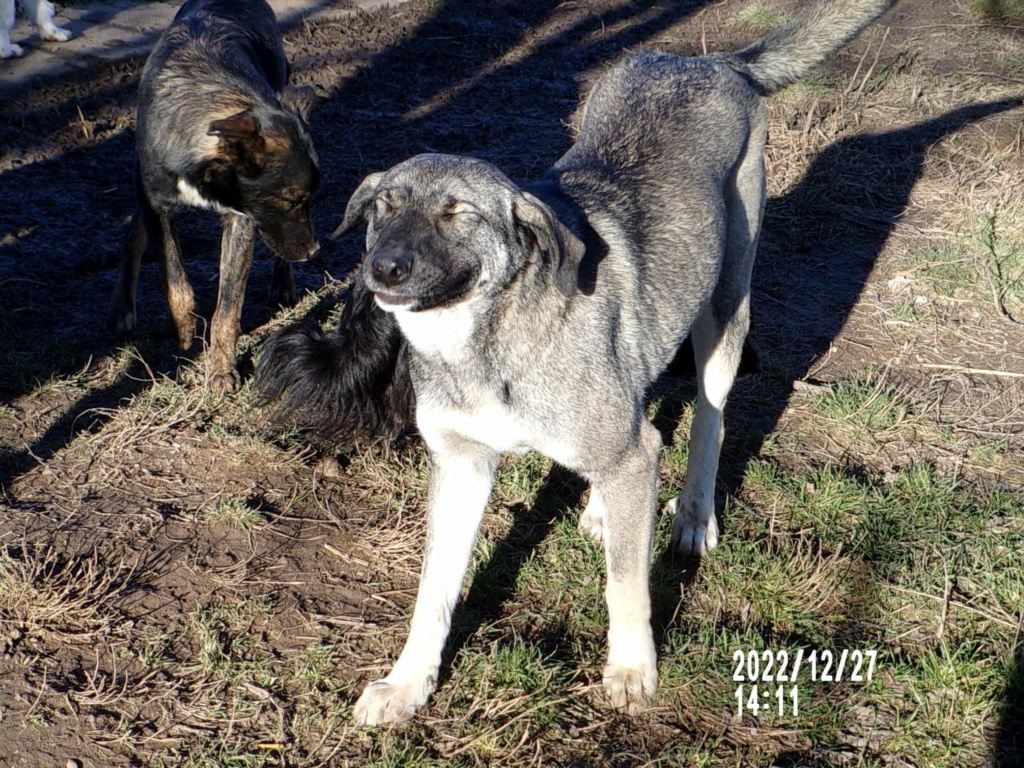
716 0 896 95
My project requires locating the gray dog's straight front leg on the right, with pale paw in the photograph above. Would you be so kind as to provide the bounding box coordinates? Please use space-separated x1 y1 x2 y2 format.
588 419 662 715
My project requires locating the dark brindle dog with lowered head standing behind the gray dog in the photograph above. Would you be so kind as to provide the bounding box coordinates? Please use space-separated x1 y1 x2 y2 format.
111 0 319 391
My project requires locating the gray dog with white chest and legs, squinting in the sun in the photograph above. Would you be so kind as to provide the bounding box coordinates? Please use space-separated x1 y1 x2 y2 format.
276 0 892 725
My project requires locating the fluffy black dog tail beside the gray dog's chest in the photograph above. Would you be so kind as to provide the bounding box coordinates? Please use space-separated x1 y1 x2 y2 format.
256 275 416 442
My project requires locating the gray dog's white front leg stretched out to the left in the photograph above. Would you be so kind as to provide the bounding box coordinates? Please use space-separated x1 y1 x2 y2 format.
355 441 498 725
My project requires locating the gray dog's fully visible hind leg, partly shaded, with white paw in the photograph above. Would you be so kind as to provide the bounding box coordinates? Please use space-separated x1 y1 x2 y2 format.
667 117 765 555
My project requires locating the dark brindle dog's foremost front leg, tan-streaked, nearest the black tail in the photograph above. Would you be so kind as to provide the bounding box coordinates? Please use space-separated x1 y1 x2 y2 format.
209 213 256 392
